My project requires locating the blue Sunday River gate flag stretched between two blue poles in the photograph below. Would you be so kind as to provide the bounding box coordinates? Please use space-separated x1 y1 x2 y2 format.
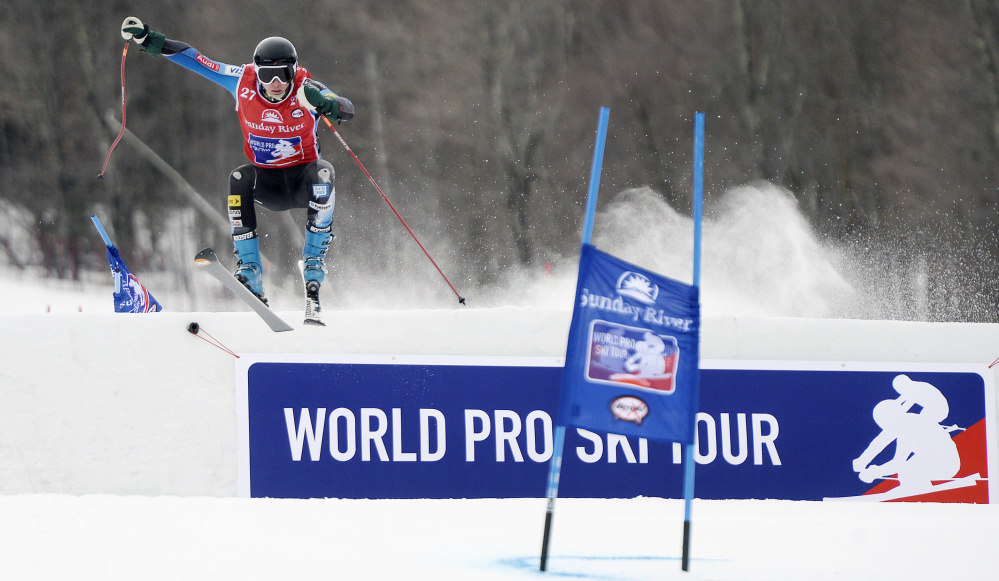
559 244 700 444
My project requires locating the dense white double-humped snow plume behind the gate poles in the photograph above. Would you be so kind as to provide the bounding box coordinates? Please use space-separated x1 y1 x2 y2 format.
594 184 853 317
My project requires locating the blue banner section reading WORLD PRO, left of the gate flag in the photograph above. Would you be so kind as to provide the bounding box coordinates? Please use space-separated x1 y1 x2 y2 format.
248 360 562 498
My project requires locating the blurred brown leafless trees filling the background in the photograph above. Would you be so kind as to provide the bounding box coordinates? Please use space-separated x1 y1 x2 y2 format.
0 0 999 318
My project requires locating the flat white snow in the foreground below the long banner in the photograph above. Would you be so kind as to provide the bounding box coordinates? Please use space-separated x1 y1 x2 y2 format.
0 494 999 581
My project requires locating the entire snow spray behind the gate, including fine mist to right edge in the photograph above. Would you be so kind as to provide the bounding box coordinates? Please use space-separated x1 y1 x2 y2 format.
594 183 992 322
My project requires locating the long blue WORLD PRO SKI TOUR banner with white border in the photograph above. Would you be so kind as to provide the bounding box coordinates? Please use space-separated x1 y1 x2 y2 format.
236 354 996 503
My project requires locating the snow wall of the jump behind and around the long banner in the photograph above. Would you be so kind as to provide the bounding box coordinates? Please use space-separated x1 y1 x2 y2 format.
0 307 999 496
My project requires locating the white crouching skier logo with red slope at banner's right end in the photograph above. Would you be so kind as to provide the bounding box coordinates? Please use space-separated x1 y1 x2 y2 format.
826 374 988 502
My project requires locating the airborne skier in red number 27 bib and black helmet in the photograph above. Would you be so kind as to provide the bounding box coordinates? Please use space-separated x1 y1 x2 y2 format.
121 16 354 325
